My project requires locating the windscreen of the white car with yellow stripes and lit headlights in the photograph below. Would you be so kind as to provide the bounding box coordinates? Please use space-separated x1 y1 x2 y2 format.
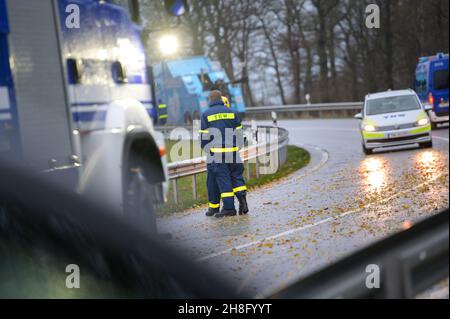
366 95 420 115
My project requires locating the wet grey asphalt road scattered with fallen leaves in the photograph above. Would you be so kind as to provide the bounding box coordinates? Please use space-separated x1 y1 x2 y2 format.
159 119 449 296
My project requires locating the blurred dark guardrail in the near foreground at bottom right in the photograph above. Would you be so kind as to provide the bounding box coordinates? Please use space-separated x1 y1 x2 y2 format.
272 209 449 299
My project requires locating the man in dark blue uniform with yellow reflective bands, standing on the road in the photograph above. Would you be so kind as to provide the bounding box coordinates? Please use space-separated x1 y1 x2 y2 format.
200 90 249 218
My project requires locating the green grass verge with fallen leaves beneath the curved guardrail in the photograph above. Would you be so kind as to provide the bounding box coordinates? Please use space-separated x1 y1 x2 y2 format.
157 145 311 216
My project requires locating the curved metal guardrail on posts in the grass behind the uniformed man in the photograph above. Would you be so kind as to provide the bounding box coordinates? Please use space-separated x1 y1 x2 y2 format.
164 125 289 205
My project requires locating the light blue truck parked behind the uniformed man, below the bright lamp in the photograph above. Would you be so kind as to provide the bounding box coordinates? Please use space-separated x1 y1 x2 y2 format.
153 56 245 126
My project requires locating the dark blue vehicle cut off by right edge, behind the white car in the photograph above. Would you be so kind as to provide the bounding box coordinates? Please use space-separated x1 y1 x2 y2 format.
415 53 449 128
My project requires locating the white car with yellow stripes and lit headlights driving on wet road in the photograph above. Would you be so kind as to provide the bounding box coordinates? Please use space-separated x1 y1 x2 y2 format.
355 90 433 155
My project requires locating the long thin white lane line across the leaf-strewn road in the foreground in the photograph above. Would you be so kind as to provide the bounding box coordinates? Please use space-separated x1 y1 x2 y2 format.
196 148 445 262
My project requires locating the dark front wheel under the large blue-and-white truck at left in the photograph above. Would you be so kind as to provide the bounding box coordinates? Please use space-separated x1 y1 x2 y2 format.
124 166 157 235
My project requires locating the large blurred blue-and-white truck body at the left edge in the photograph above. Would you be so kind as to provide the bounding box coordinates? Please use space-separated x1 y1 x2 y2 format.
0 0 172 231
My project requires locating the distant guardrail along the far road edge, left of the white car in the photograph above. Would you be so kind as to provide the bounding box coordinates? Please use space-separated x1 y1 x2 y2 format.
245 102 364 118
